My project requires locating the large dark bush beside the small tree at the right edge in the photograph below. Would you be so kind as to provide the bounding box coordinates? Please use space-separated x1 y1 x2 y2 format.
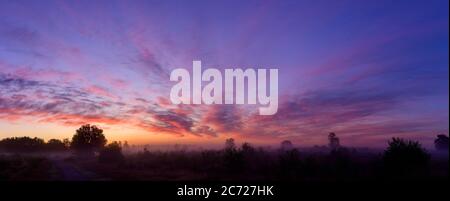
383 138 430 177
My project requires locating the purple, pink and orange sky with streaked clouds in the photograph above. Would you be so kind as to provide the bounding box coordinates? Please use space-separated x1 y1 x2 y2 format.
0 0 449 147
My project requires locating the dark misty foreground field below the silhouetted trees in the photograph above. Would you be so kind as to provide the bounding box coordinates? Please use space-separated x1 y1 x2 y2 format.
0 146 449 182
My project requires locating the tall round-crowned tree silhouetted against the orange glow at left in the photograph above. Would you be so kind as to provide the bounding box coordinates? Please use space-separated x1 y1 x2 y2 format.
70 124 107 155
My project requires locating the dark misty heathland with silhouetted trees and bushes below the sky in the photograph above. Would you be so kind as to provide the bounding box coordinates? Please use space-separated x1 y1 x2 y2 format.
0 125 449 182
